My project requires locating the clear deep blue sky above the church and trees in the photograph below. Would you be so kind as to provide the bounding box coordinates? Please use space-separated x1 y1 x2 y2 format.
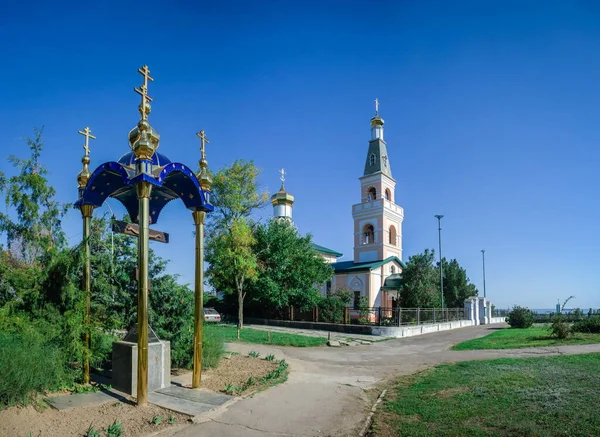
0 1 600 308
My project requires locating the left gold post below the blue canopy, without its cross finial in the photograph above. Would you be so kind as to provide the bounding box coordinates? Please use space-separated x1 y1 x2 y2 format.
81 205 94 384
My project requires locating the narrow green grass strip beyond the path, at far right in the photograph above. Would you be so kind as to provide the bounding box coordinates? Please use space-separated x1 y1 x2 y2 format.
452 325 600 351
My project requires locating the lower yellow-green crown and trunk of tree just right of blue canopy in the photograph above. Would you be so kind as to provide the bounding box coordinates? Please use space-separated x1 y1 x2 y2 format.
206 217 258 329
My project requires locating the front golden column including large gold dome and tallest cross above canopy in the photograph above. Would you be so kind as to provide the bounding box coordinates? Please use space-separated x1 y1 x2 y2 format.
129 65 160 406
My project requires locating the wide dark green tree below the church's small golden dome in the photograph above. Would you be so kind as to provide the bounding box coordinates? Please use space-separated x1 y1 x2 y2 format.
252 220 333 310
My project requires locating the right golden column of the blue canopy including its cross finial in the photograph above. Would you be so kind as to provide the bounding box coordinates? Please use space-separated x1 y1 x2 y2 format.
192 130 212 388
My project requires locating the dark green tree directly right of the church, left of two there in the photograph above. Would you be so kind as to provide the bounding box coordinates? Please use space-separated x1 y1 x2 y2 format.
400 249 440 308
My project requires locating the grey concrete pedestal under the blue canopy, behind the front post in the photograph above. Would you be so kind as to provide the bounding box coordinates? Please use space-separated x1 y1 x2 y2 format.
112 325 171 396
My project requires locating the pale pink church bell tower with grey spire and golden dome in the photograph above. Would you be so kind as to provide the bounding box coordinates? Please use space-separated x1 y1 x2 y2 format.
352 99 404 263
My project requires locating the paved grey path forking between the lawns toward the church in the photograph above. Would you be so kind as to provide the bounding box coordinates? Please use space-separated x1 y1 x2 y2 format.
161 325 600 437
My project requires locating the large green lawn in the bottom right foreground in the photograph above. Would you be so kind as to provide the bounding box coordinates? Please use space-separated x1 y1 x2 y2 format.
370 353 600 437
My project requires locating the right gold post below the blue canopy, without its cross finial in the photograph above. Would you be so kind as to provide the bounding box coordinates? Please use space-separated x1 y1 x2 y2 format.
192 211 206 388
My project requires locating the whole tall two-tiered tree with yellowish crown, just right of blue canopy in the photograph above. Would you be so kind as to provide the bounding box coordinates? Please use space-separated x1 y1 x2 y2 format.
206 160 268 329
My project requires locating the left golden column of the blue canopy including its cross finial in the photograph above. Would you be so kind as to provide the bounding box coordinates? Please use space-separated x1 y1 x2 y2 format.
77 127 96 384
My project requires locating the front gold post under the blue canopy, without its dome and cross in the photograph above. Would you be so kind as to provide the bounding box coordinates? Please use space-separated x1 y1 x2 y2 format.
135 181 152 407
